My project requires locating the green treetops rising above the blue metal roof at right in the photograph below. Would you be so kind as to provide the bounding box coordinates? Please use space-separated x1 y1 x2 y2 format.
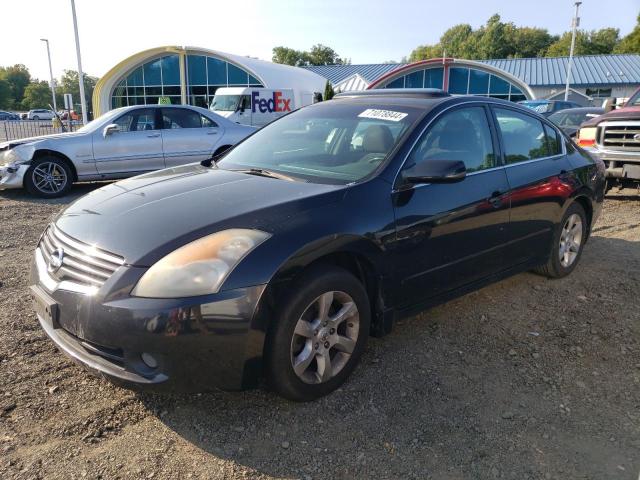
409 14 628 62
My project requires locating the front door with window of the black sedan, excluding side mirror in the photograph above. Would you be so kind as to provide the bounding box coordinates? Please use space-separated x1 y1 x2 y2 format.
393 105 509 306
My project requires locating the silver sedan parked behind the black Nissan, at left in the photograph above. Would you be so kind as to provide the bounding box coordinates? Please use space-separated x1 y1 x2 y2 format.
0 105 255 198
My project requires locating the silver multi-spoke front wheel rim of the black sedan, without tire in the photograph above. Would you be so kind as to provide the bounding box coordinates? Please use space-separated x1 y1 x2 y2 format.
291 292 360 384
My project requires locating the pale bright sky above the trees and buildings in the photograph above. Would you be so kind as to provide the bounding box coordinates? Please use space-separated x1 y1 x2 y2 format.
0 0 640 80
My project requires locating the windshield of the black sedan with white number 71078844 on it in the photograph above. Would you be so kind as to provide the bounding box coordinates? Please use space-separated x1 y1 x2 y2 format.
218 100 421 184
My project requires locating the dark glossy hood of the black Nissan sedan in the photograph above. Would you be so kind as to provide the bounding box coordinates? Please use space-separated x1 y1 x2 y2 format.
55 164 345 266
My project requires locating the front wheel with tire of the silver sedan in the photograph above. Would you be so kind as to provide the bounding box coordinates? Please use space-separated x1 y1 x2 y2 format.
24 155 73 198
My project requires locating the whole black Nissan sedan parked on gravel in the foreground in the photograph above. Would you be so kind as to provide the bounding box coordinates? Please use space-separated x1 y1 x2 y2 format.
31 90 604 400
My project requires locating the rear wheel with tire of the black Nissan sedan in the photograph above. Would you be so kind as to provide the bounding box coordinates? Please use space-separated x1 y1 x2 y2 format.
535 202 587 278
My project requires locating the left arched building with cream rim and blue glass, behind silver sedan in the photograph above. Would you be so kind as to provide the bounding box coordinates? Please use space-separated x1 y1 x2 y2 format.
93 47 326 117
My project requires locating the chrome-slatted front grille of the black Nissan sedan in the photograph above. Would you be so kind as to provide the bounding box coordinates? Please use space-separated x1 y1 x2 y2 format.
39 224 124 287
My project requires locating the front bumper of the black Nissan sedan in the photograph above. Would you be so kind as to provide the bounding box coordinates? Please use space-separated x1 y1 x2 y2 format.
30 249 265 392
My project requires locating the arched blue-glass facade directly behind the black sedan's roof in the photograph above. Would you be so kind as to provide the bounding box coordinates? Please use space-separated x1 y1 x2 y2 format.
368 58 535 102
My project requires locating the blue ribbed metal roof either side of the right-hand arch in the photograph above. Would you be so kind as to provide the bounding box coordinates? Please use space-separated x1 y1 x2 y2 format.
304 54 640 87
